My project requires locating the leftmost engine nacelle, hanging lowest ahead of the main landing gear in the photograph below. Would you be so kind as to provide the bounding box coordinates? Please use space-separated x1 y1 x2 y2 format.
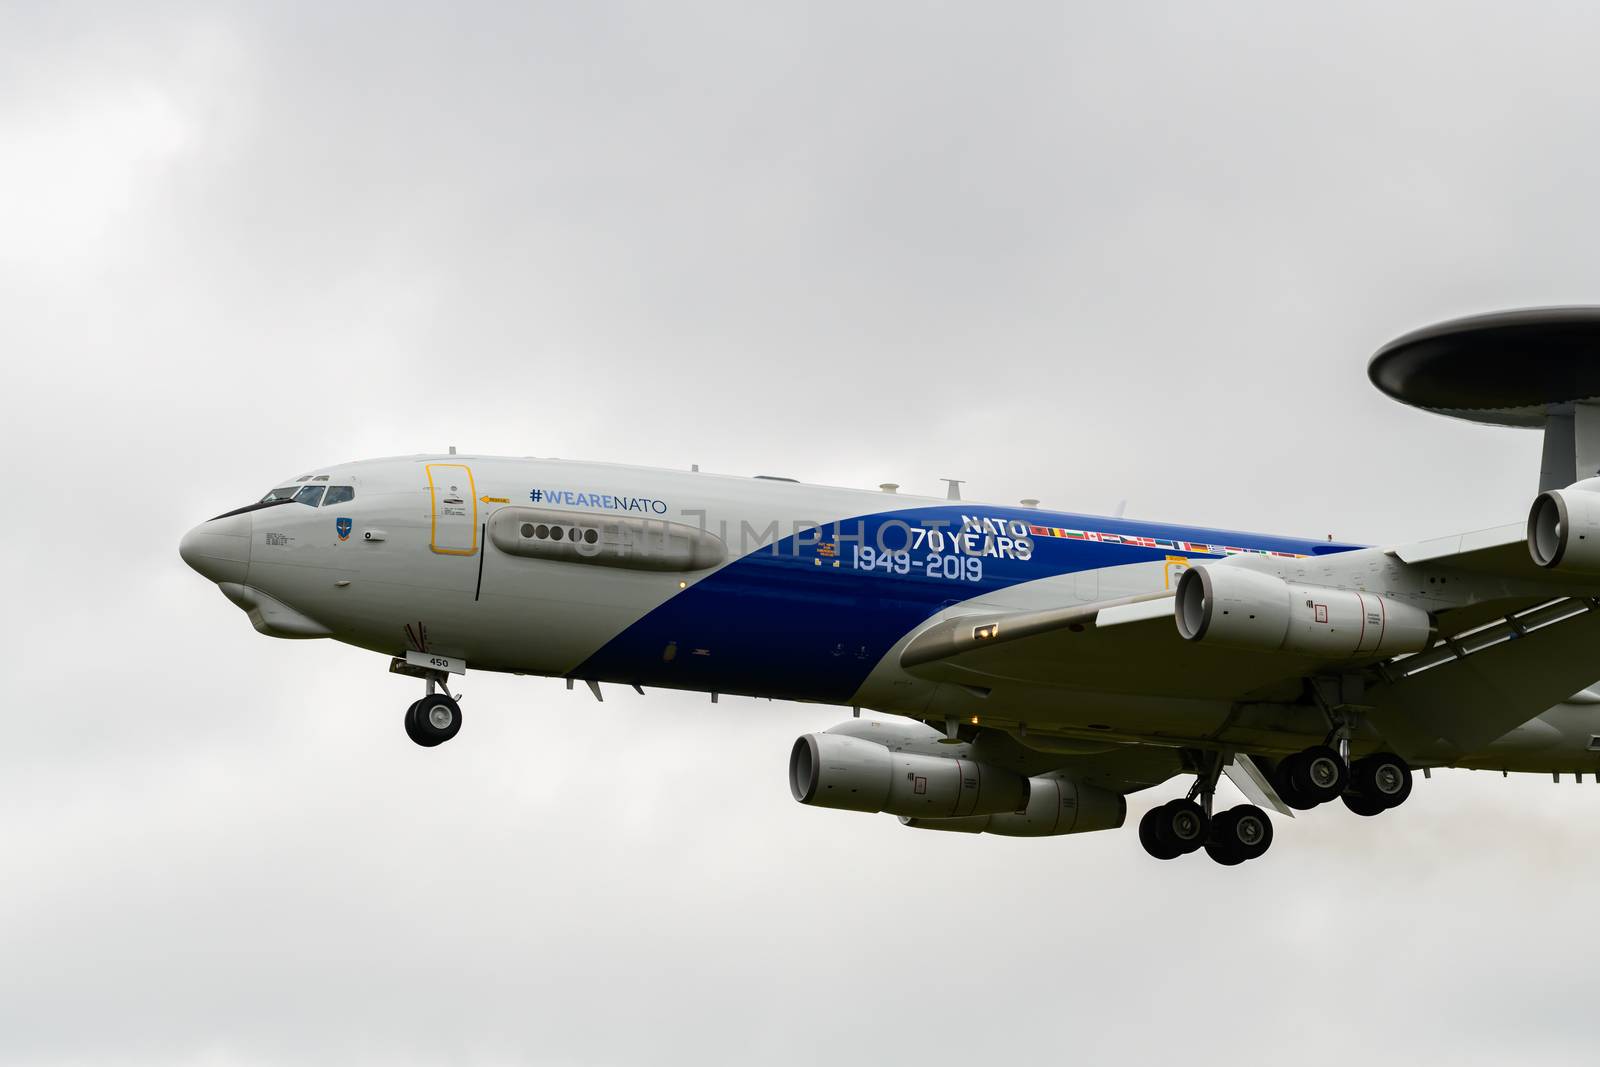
789 733 1029 819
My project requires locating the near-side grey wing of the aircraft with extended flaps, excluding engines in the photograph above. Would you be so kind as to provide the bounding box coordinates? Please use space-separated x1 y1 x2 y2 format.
901 526 1600 763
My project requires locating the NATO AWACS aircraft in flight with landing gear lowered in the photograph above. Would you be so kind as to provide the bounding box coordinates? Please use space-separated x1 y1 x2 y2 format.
181 309 1600 864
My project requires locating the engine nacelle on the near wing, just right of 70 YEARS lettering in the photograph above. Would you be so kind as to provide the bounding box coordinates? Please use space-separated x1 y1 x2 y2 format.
1173 563 1434 659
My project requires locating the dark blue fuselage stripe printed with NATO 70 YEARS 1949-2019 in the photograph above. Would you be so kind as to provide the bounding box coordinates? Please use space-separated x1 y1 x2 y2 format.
574 506 1360 704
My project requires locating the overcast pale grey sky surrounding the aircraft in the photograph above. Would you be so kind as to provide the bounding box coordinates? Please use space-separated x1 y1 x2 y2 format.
0 2 1600 1064
